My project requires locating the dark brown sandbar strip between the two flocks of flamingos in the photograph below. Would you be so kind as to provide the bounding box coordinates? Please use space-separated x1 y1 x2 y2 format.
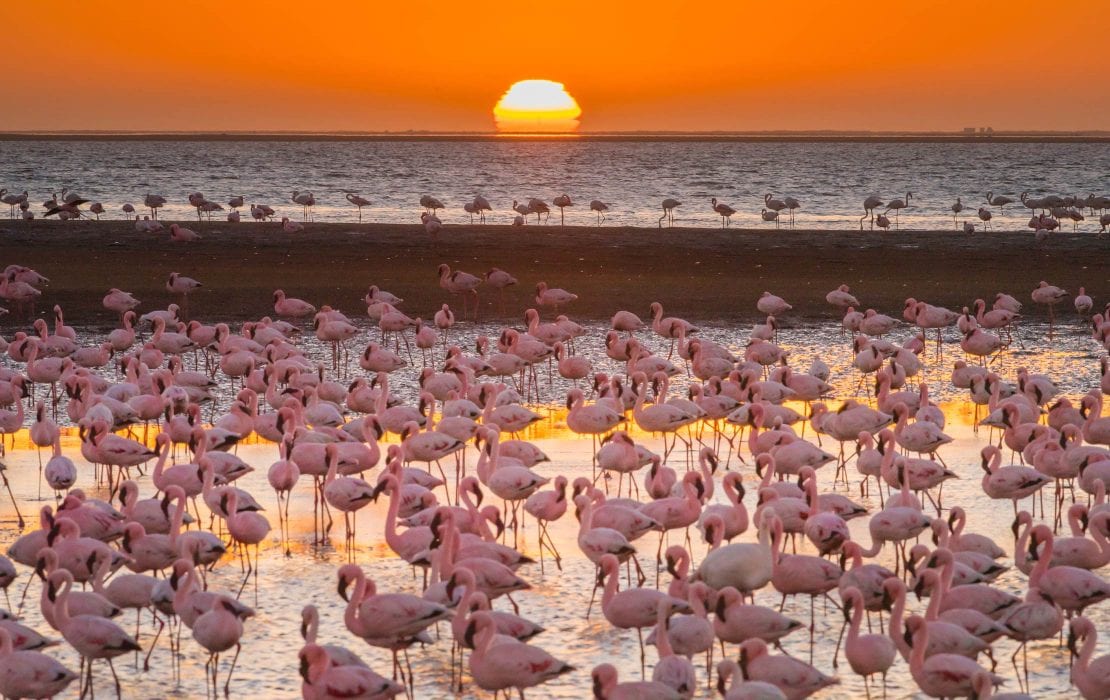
0 221 1110 328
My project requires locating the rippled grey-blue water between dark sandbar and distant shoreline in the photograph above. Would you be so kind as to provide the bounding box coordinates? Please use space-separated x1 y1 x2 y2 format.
0 140 1110 231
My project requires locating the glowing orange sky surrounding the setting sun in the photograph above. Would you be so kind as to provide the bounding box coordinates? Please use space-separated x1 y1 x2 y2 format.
0 0 1110 131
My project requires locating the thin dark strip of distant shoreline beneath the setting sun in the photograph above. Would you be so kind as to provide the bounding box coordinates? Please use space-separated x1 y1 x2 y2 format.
0 131 1110 144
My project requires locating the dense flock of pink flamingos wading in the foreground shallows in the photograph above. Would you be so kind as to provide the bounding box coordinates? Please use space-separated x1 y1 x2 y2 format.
0 235 1110 699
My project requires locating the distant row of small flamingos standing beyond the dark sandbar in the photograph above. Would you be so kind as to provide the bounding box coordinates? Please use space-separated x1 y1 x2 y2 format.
0 189 1110 240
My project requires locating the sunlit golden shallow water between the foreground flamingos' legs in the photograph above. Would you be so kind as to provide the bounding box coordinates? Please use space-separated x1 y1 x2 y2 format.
0 322 1110 698
